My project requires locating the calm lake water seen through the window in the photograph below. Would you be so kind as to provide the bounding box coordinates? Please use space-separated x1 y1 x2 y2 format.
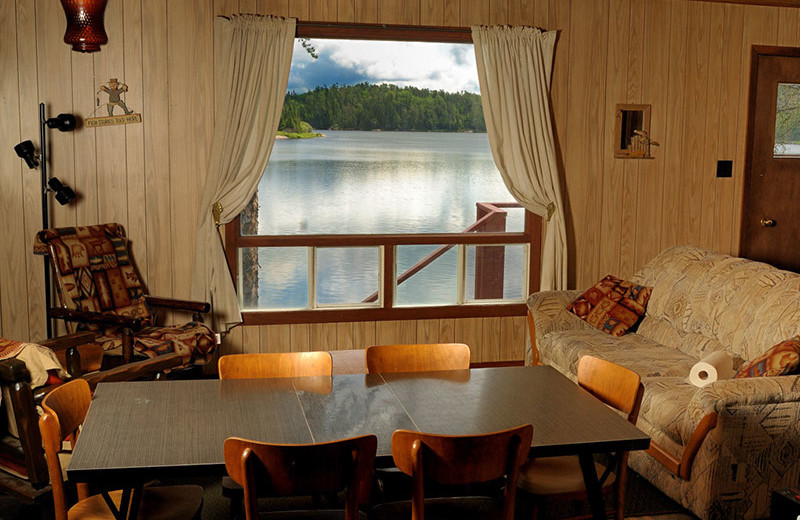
243 130 526 309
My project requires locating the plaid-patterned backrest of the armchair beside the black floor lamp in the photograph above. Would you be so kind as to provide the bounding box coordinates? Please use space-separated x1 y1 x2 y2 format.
34 223 152 330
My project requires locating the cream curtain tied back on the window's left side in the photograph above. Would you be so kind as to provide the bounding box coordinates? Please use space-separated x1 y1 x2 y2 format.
192 15 295 331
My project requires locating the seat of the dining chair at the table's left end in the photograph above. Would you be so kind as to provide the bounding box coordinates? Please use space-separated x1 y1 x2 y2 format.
68 486 203 520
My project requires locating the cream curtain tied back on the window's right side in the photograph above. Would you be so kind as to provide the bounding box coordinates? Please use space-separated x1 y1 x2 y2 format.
472 26 567 290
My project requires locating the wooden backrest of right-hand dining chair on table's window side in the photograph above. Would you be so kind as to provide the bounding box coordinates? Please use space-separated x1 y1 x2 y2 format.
366 343 469 374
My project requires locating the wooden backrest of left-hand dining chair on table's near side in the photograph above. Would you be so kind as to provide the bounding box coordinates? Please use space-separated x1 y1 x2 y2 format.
225 435 378 520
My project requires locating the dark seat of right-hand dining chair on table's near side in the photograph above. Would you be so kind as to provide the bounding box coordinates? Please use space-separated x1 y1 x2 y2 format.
369 497 503 520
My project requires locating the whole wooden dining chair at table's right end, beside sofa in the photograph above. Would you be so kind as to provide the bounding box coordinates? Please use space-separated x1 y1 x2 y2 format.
519 356 644 520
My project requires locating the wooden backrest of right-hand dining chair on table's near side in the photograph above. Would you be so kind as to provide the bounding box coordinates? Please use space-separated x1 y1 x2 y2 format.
392 424 533 520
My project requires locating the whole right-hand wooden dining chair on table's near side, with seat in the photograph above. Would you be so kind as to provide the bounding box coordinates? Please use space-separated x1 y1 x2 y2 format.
370 424 533 520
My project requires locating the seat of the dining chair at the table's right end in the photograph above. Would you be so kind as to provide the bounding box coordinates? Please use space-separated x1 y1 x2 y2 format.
517 455 616 495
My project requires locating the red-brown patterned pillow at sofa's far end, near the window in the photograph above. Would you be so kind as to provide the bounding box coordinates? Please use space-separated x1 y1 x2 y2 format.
567 275 653 336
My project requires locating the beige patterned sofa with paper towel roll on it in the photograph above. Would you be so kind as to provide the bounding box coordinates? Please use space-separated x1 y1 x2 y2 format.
526 246 800 520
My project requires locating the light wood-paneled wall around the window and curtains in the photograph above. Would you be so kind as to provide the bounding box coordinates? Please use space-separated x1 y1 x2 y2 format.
0 0 800 361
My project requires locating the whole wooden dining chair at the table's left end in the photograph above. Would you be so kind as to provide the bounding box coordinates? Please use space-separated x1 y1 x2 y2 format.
39 379 203 520
